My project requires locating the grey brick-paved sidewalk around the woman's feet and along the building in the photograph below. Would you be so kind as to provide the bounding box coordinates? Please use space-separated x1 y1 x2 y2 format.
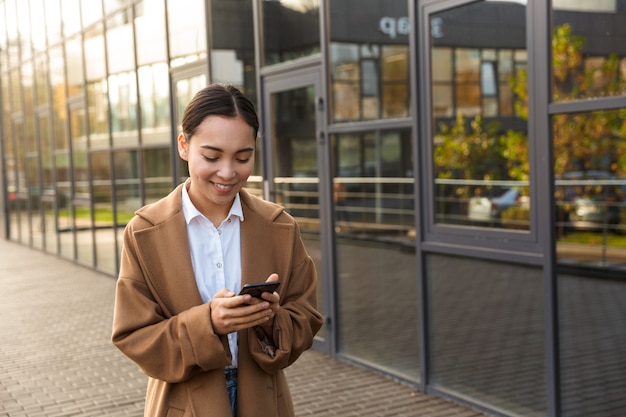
0 240 484 417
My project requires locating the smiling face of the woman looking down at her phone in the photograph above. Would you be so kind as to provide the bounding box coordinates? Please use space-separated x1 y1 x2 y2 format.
178 116 256 220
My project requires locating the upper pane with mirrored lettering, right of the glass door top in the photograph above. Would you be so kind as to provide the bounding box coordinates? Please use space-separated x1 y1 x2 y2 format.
330 0 410 122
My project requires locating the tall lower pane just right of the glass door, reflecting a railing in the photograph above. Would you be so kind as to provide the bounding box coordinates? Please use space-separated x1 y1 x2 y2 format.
331 129 419 380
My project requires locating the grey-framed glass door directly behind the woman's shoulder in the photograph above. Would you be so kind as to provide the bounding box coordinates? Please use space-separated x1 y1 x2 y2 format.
263 68 333 352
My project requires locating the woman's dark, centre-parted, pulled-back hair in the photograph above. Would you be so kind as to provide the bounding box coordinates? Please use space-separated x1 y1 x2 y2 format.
182 84 259 140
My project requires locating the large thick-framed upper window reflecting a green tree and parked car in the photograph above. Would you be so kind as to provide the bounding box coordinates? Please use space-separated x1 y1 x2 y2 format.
430 1 531 231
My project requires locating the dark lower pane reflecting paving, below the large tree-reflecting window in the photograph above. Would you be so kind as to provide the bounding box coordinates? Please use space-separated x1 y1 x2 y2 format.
426 254 548 417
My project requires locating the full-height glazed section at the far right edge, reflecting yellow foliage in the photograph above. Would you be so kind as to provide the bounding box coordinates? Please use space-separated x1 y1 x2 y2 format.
550 0 626 417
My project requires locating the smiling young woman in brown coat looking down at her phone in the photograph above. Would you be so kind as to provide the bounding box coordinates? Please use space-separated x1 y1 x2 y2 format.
112 85 322 417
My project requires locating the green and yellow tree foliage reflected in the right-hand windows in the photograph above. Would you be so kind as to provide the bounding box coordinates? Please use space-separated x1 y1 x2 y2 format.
434 24 626 181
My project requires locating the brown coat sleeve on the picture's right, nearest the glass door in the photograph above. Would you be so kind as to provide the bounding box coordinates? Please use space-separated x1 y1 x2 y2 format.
247 219 323 374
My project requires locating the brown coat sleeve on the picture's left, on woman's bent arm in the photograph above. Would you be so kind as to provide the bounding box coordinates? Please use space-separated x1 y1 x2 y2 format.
112 222 231 383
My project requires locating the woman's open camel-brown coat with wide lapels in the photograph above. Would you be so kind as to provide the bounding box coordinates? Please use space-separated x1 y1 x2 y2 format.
112 185 322 417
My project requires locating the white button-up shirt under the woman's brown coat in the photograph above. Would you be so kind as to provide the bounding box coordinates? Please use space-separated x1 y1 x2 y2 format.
183 185 243 368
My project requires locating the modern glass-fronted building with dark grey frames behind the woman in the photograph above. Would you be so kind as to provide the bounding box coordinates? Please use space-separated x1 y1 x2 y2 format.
0 0 626 417
